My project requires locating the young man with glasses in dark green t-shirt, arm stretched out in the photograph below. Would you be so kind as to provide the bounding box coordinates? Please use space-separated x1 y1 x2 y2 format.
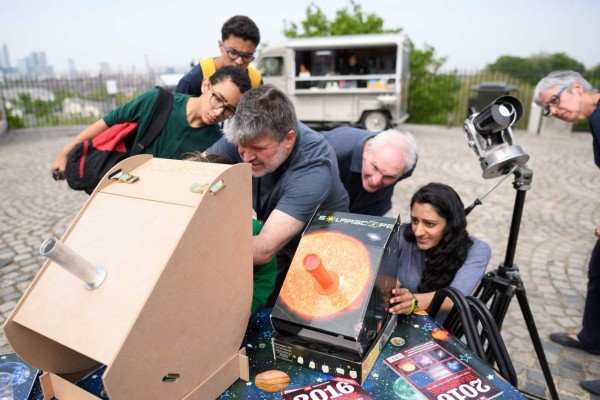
50 66 250 175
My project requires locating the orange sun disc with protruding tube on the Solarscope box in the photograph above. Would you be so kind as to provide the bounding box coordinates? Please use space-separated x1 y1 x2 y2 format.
279 232 371 317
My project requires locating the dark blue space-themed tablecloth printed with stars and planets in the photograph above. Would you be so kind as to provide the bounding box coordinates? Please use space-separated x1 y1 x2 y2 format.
219 310 524 400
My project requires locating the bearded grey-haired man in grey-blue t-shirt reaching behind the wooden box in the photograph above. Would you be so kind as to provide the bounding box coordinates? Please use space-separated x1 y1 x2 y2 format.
206 85 348 305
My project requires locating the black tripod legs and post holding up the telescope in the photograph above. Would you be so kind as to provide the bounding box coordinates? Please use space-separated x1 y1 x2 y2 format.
474 166 559 400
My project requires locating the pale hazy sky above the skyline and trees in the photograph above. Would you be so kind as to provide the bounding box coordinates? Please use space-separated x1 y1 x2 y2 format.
0 0 600 72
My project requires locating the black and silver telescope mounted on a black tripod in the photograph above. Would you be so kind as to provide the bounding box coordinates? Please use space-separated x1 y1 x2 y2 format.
462 96 559 400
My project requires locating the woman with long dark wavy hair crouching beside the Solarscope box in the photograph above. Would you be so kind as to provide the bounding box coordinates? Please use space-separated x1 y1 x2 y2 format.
381 183 491 314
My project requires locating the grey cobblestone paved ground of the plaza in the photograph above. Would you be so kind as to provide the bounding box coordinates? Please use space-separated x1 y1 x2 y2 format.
0 126 600 399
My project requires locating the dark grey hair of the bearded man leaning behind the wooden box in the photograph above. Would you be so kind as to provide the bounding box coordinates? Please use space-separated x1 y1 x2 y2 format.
225 84 298 145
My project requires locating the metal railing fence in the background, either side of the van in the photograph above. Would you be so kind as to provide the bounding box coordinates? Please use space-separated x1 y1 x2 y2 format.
0 70 600 130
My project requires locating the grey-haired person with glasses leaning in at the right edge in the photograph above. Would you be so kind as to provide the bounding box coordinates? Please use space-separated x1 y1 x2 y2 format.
533 71 600 396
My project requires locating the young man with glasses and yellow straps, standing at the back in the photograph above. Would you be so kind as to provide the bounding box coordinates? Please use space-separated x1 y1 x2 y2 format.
175 15 261 96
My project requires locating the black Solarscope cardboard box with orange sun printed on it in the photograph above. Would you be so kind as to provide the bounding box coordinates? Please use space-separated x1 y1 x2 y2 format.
271 211 399 383
